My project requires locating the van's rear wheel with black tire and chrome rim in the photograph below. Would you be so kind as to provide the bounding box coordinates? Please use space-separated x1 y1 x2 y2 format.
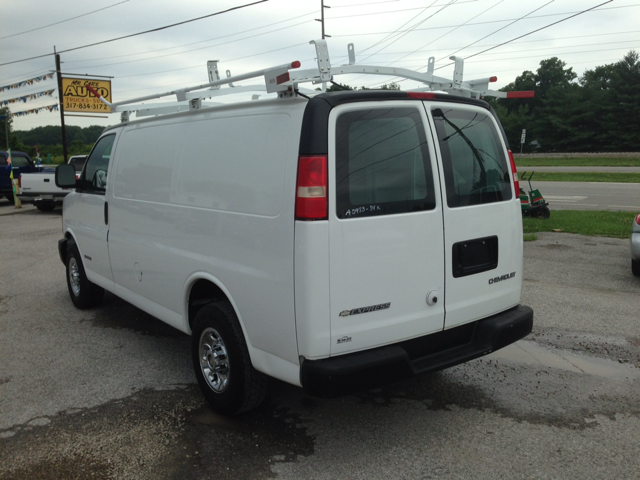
191 301 268 415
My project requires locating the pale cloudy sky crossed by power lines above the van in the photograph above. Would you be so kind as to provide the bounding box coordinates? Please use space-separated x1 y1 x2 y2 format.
0 0 640 130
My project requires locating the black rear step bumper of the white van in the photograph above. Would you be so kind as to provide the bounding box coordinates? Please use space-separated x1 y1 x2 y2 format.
300 305 533 397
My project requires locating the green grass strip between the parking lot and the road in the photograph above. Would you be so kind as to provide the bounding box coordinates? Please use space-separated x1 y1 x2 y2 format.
522 210 638 240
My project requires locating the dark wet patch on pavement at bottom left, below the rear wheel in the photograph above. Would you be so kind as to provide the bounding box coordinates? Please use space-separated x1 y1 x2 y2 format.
0 385 315 480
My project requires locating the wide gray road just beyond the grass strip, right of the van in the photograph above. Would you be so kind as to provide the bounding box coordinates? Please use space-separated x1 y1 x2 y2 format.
520 181 640 212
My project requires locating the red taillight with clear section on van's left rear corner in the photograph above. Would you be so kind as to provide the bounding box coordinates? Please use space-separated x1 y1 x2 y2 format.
296 156 328 220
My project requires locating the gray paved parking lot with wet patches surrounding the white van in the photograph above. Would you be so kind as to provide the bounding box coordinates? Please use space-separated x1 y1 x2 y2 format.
0 203 640 480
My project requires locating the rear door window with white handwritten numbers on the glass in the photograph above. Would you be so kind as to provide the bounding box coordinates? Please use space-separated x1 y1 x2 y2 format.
336 108 435 218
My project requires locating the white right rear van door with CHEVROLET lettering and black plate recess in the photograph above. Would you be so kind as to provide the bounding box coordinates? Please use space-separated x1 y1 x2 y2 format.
425 102 522 328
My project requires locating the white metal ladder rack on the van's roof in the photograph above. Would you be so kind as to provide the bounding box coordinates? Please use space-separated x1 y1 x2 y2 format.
87 40 534 122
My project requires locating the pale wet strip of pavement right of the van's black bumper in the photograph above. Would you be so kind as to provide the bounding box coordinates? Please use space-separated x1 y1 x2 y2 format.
488 341 640 380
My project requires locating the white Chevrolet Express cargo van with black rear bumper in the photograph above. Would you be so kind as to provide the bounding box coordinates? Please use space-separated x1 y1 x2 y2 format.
56 43 533 414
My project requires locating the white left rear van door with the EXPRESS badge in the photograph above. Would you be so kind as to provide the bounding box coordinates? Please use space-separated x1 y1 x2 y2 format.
328 101 444 354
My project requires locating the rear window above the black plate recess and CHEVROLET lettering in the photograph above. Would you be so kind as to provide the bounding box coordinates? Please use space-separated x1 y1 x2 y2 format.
431 108 511 208
